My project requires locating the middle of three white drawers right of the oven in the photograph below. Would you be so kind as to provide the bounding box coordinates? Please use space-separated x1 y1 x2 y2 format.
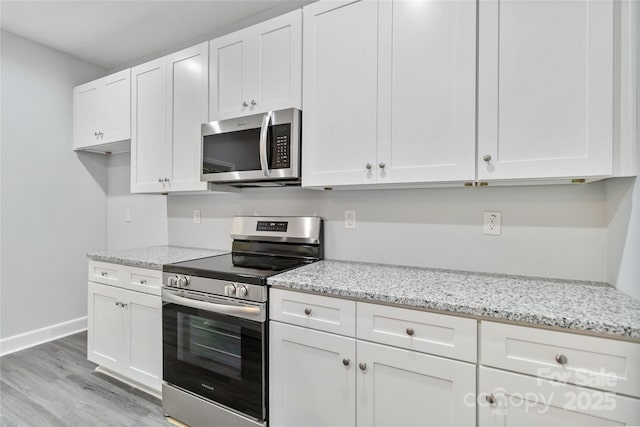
357 302 477 363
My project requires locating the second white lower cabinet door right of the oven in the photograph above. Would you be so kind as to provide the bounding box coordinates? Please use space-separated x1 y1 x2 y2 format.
357 340 476 427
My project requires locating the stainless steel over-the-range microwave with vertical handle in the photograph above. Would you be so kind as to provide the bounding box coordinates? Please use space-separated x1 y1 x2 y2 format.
201 108 302 186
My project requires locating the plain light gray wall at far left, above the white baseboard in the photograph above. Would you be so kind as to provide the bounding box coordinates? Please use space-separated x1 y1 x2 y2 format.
0 32 107 338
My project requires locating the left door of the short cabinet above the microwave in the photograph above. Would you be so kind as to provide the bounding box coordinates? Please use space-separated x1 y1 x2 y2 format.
209 31 250 121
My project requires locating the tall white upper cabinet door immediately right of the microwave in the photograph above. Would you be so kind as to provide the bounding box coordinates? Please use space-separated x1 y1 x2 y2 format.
302 0 378 187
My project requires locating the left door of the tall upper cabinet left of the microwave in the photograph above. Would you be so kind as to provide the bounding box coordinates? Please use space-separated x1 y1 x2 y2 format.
131 58 170 193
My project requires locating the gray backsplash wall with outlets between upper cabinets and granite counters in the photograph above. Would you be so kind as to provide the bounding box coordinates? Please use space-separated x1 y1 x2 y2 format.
168 182 607 281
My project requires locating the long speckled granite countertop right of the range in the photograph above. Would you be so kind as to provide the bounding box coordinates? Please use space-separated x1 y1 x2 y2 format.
268 260 640 340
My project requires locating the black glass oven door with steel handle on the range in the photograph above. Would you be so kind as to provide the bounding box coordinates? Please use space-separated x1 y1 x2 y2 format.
162 288 267 421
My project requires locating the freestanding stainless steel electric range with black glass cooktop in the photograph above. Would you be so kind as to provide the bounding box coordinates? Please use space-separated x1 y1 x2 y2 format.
162 217 324 427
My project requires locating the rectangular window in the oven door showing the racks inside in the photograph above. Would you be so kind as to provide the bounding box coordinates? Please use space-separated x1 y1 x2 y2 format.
178 313 242 379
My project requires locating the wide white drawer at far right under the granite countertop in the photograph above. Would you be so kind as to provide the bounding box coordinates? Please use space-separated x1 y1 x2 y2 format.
480 322 640 396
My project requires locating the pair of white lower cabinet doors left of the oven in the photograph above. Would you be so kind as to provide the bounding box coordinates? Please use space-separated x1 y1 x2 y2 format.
87 282 162 391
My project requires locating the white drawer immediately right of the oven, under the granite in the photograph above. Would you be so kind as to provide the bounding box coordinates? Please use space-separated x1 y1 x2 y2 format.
269 289 356 337
